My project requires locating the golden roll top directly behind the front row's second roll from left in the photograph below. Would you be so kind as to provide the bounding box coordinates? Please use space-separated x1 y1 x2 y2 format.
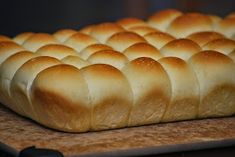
87 50 128 70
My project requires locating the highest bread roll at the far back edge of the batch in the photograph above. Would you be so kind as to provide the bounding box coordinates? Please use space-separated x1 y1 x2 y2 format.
148 9 183 31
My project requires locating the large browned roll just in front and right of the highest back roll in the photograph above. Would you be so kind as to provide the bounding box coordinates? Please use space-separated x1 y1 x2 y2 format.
167 13 213 38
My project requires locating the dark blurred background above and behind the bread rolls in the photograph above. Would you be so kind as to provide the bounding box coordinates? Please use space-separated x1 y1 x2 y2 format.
0 0 235 37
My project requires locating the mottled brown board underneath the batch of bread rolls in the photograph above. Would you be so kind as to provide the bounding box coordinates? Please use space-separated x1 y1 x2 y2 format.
0 105 235 156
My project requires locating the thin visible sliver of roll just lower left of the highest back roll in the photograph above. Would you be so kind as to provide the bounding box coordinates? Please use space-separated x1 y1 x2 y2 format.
128 26 159 36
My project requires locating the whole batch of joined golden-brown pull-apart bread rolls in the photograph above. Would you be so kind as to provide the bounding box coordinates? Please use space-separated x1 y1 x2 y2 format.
0 9 235 132
